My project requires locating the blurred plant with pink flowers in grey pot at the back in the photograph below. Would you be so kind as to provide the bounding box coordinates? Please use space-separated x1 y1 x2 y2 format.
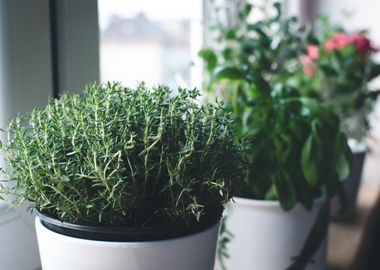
299 17 380 217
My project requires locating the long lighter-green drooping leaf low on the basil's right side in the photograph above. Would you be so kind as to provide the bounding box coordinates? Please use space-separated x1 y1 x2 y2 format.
301 135 318 186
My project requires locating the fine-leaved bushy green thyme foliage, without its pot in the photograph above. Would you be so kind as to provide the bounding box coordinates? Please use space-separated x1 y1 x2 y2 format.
2 83 240 228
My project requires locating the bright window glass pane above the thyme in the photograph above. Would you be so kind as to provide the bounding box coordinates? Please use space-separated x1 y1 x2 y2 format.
99 0 202 87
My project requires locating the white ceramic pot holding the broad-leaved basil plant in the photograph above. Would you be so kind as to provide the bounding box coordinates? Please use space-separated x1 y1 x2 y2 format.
225 197 326 270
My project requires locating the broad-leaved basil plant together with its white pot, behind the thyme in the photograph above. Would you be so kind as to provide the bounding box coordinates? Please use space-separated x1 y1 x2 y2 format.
199 4 351 270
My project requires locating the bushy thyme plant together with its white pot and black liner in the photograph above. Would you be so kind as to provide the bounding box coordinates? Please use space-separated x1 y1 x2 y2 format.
1 83 241 270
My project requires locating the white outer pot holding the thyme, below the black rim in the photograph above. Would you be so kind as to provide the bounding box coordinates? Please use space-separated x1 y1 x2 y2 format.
36 217 219 270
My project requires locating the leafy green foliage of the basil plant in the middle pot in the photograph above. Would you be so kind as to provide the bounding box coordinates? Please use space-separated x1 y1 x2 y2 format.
199 3 352 270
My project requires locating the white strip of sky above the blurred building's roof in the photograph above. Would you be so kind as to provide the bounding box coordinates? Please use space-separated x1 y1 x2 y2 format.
98 0 202 29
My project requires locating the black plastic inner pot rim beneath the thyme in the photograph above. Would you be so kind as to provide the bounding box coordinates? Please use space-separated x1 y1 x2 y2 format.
35 210 222 242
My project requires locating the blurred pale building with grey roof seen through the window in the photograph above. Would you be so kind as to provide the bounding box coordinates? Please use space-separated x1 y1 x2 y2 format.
100 13 191 87
